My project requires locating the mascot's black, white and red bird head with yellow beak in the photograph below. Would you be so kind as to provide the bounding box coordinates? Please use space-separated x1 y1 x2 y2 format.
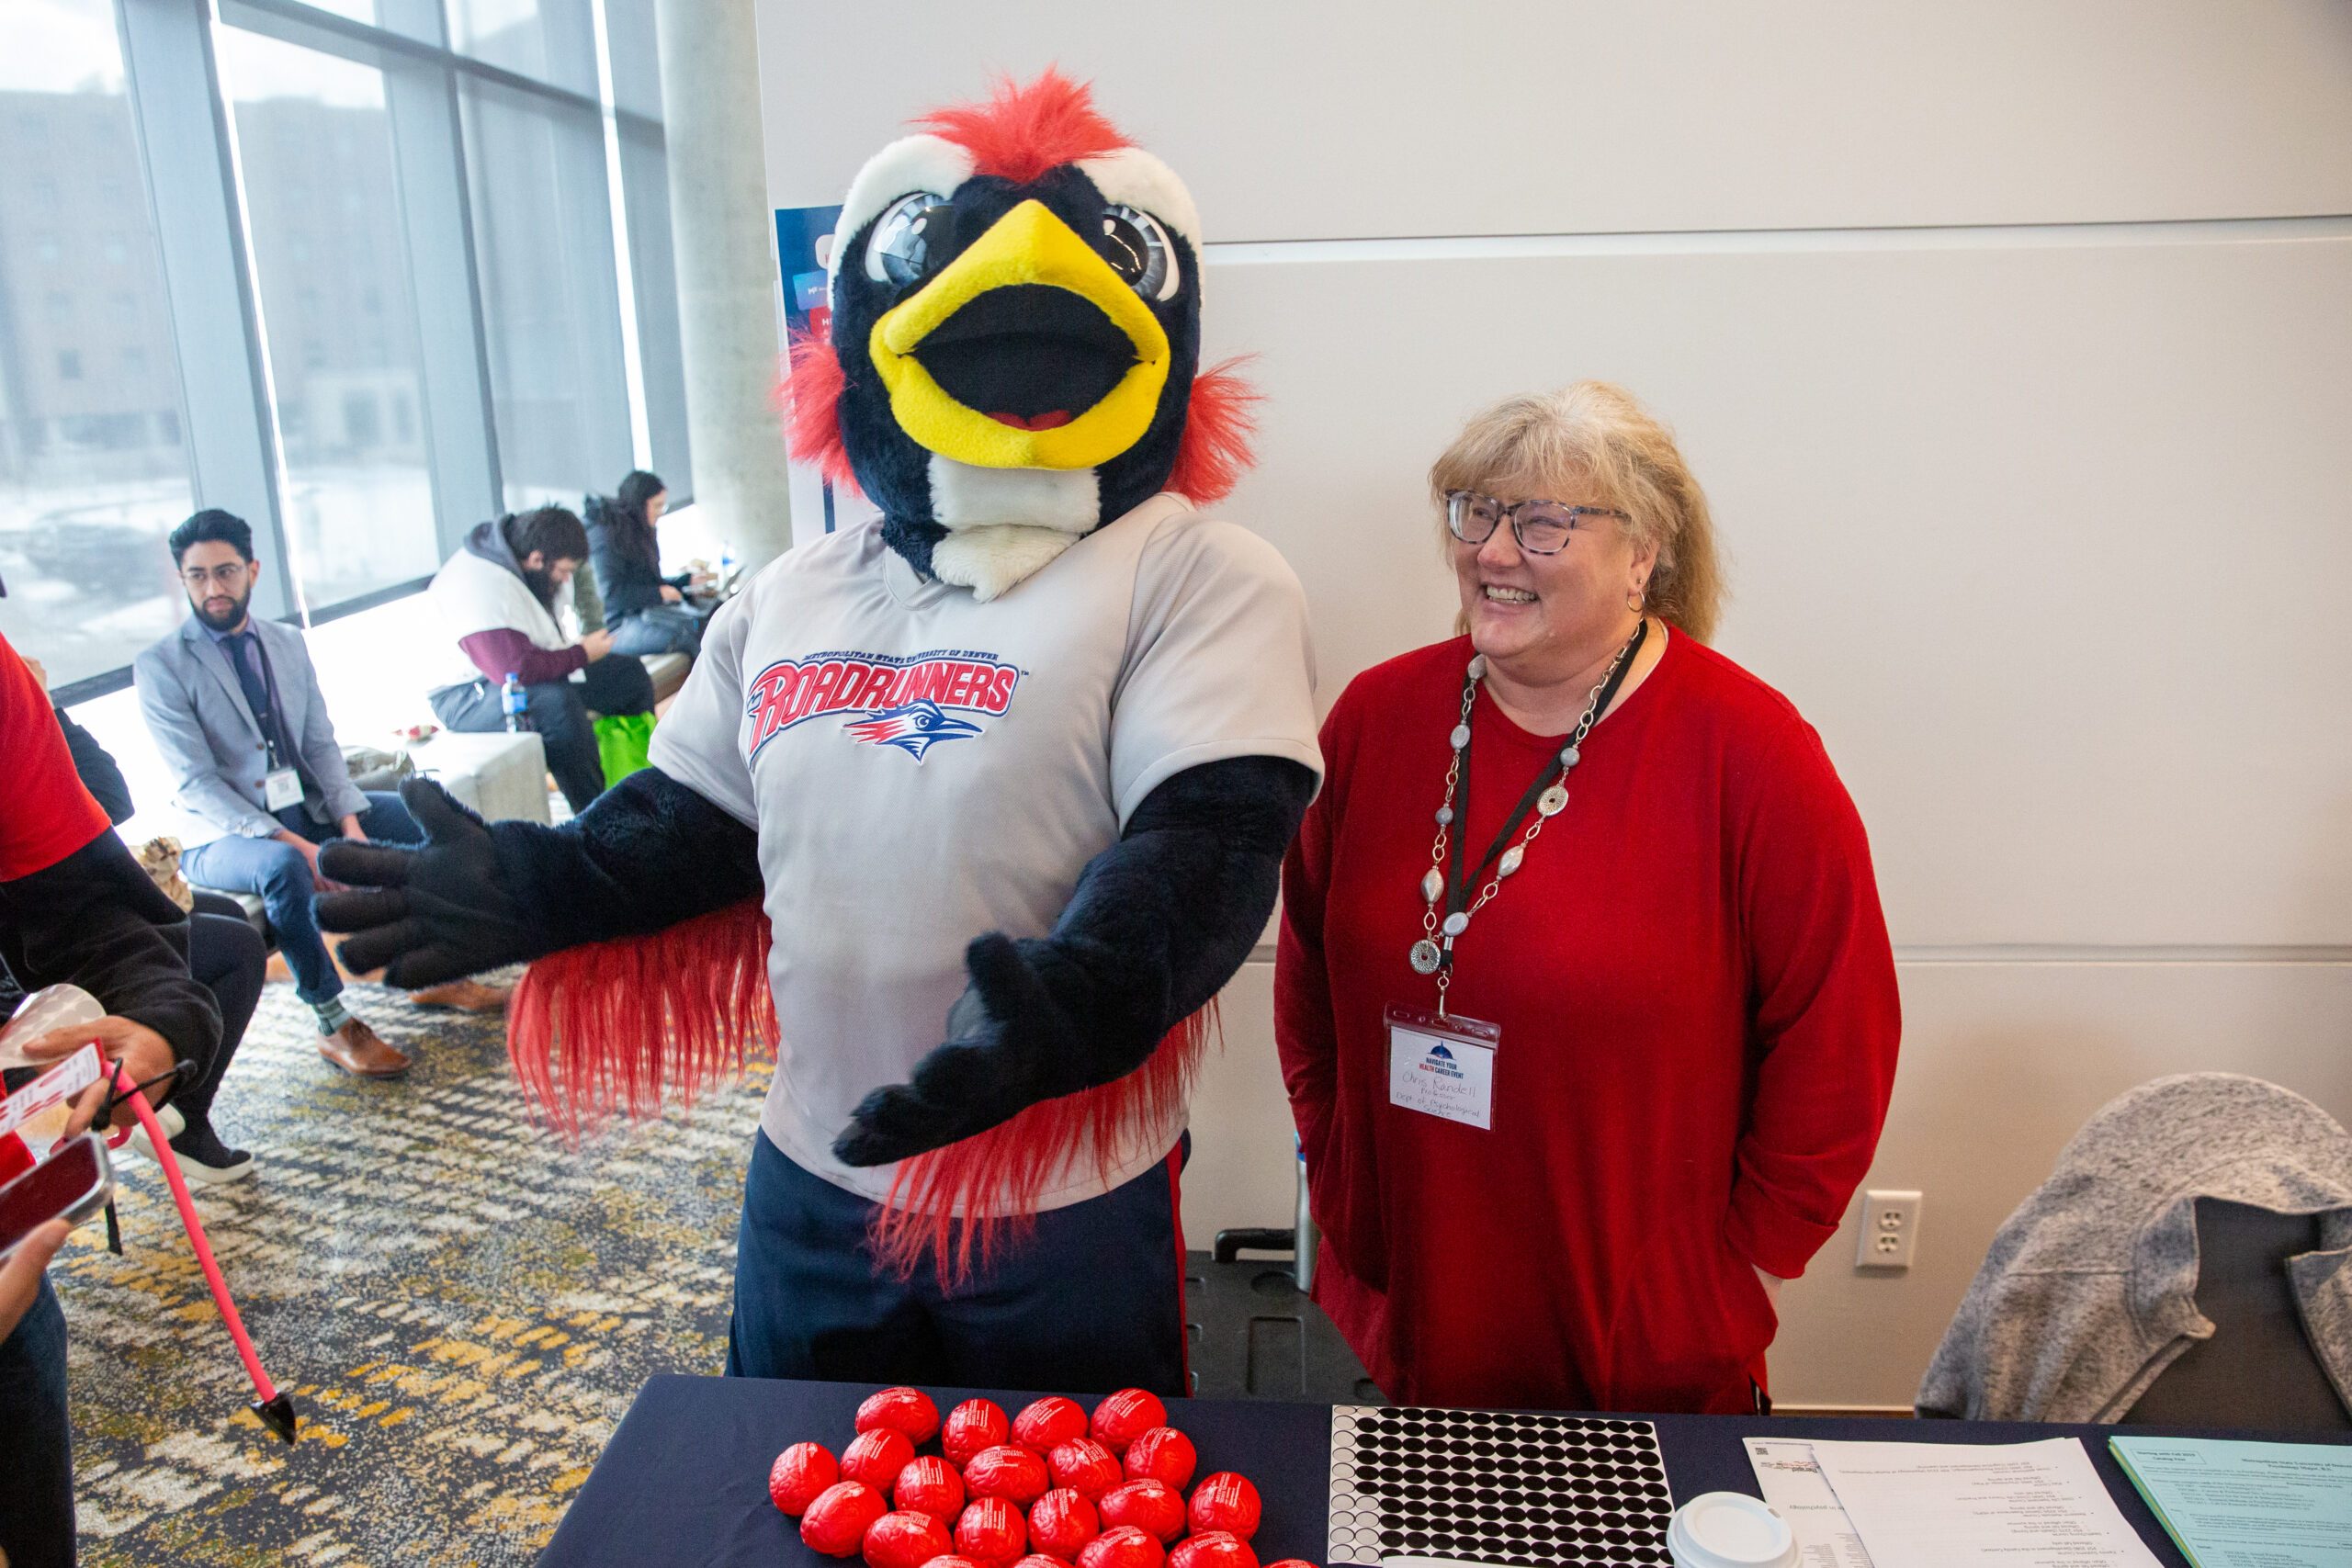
788 71 1253 600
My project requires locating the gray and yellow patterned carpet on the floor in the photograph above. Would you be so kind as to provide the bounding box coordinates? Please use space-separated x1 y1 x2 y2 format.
51 985 767 1568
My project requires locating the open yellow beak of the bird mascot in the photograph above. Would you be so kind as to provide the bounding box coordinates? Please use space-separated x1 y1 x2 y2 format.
865 200 1169 468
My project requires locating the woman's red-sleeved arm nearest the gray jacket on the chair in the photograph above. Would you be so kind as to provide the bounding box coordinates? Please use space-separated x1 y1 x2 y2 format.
1726 728 1903 1279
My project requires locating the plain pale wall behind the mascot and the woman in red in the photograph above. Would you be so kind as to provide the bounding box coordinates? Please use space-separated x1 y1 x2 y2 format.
760 0 2352 1405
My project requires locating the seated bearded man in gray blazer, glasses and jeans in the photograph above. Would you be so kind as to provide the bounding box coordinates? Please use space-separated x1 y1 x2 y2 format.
131 510 503 1079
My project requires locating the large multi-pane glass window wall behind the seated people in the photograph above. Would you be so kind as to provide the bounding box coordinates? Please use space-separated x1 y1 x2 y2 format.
0 0 692 698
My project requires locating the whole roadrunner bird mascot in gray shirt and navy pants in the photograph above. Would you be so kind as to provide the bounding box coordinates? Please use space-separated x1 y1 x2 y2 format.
320 71 1322 1392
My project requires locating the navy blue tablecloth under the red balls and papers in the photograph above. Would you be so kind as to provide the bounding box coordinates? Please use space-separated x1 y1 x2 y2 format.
541 1378 2328 1568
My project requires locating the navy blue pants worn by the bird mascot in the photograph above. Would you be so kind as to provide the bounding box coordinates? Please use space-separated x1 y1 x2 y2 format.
727 1134 1190 1394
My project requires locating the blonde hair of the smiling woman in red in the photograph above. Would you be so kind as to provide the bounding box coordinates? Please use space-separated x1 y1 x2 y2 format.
1430 381 1724 642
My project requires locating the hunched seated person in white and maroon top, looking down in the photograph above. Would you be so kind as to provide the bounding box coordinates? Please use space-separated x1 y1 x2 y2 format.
430 505 654 811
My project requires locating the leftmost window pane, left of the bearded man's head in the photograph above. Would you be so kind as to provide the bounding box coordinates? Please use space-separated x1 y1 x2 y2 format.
0 0 193 684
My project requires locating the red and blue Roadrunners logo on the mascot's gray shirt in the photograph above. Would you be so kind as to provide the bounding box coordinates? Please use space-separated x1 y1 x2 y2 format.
743 649 1021 761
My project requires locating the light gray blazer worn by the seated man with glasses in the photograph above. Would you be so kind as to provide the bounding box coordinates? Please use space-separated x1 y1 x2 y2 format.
131 616 367 846
